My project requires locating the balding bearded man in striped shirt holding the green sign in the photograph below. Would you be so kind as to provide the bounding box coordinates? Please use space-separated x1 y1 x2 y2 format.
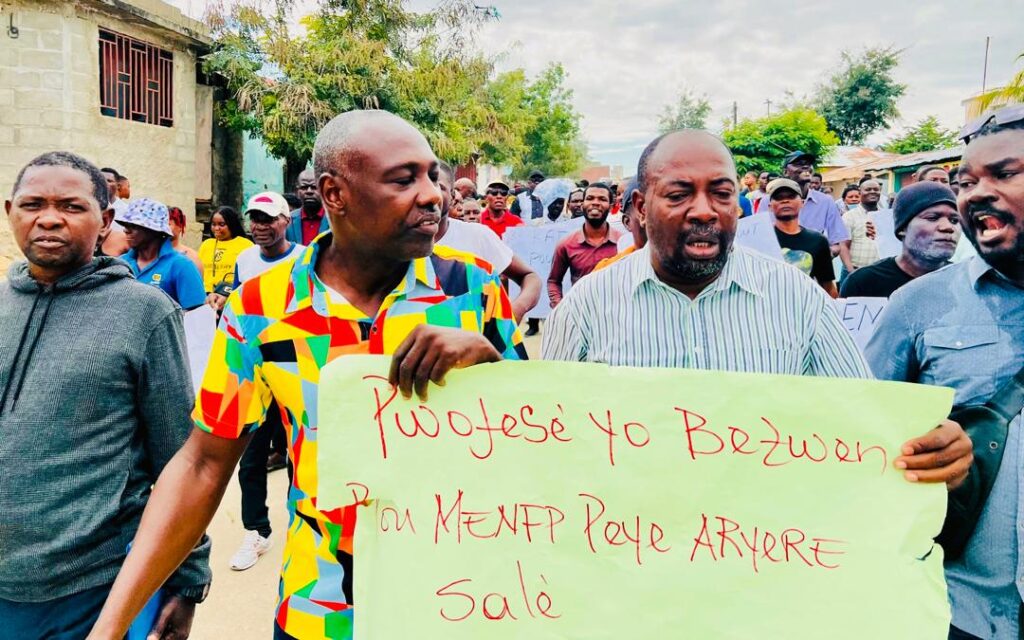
543 130 972 487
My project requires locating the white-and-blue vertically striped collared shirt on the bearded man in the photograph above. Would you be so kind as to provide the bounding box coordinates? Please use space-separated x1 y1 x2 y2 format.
542 241 871 378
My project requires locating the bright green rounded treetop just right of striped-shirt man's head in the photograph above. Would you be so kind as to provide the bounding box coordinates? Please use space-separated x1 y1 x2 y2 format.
722 109 839 175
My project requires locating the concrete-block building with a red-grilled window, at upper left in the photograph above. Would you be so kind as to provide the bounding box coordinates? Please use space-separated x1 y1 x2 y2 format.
0 0 242 267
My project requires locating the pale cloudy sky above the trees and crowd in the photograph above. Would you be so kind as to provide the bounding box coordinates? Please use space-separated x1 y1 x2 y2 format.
163 0 1024 174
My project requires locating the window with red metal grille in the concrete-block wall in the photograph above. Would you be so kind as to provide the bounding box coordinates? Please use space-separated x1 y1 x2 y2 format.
99 29 174 127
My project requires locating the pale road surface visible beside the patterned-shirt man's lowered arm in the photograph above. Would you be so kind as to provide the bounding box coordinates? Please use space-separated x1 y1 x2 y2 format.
191 329 541 640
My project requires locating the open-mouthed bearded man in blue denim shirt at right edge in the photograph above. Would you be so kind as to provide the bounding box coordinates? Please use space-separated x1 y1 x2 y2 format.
866 106 1024 640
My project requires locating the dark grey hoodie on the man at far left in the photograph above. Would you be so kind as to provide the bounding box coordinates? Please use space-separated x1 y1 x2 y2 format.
0 258 210 602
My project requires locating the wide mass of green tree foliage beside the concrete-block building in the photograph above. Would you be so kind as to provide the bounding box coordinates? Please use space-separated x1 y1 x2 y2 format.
204 0 580 182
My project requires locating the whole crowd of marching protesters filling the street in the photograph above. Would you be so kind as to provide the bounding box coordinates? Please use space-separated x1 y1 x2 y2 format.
0 100 1024 640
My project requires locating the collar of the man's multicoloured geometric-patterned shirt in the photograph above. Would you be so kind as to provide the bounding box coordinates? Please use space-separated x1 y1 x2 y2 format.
286 231 441 319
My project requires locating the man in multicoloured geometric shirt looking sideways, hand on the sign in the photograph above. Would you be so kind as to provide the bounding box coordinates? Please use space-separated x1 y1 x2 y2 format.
89 111 525 640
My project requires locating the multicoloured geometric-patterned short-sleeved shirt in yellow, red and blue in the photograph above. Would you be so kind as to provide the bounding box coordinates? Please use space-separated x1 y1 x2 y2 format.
193 232 526 640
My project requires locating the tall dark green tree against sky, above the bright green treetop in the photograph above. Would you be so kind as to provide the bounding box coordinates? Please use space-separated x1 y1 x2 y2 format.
815 47 906 144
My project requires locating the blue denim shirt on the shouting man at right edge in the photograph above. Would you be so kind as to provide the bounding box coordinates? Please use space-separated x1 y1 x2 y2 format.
865 256 1024 640
